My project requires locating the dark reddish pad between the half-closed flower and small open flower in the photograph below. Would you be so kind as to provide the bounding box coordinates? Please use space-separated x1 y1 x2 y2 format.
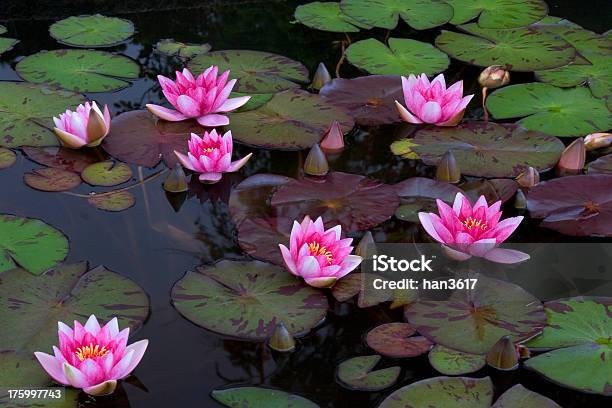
102 110 205 168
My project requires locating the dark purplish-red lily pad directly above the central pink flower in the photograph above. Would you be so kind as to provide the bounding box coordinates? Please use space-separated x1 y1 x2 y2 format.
271 172 399 231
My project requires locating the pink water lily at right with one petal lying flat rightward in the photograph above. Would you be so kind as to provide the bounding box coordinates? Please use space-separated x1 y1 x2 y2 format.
419 193 529 263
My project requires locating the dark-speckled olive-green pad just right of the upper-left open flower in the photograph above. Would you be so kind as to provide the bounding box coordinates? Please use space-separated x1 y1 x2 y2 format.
230 89 354 150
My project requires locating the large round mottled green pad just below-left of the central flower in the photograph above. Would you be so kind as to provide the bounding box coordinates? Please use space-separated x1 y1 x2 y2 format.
171 260 328 340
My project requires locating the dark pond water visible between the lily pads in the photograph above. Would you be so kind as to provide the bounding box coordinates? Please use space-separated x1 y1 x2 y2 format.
0 0 612 408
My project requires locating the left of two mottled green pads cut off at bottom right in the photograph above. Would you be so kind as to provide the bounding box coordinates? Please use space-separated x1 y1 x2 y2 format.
378 377 493 408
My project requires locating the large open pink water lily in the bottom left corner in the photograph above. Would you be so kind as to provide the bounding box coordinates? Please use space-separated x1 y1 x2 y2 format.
34 315 149 395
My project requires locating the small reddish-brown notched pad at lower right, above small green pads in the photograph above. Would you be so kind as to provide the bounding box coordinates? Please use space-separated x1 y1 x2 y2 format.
366 323 433 358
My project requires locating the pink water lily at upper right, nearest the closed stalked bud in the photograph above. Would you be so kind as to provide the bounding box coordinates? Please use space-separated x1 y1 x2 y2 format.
395 74 474 126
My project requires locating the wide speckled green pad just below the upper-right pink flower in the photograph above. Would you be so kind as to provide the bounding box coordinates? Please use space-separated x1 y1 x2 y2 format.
404 122 564 177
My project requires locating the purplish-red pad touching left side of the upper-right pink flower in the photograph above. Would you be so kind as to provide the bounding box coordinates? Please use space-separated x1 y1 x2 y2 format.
319 75 404 126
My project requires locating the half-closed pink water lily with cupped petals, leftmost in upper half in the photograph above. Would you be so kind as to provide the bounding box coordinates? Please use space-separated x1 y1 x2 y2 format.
53 102 110 149
